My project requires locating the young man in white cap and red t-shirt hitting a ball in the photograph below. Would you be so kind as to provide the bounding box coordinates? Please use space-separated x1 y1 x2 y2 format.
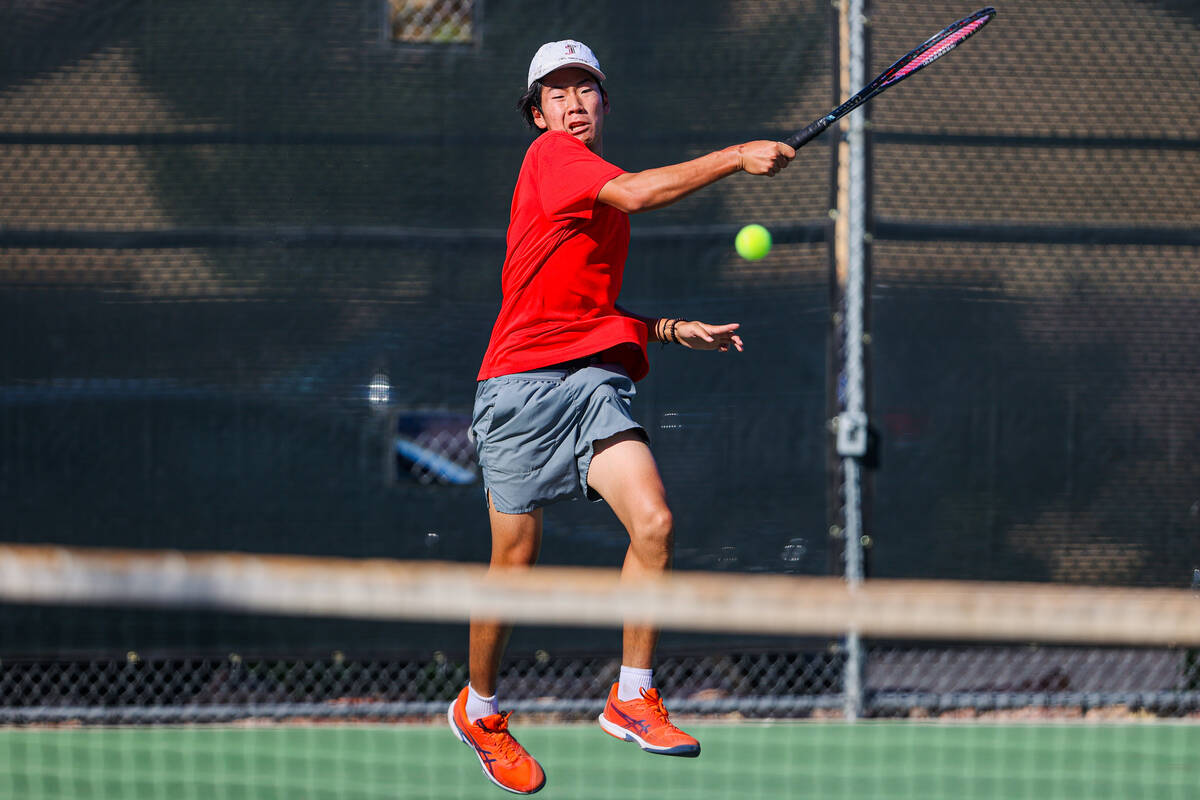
448 41 796 794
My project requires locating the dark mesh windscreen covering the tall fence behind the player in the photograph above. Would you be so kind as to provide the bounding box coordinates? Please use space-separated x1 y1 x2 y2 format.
0 0 1200 652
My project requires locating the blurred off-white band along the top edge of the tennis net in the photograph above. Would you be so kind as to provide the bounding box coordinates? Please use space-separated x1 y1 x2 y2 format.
0 545 1200 645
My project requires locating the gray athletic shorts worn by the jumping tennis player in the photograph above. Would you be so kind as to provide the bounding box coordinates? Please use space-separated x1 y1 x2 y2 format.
470 363 647 513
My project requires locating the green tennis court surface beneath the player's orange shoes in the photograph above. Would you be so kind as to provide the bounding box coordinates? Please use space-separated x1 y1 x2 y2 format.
0 722 1200 800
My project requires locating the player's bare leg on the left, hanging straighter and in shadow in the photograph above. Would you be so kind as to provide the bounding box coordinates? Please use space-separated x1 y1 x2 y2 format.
469 498 541 697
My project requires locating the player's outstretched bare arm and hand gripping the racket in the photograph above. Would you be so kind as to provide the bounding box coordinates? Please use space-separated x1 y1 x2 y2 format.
598 140 796 213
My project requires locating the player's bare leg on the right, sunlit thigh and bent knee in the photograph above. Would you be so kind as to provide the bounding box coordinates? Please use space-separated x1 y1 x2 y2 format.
588 431 674 669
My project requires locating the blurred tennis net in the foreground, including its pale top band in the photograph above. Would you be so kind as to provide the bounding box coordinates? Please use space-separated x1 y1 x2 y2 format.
0 546 1200 799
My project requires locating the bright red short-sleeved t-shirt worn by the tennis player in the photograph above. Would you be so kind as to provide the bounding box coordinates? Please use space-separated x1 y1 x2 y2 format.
479 131 649 380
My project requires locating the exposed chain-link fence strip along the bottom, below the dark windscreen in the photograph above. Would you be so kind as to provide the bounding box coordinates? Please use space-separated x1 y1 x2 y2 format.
0 643 1200 724
